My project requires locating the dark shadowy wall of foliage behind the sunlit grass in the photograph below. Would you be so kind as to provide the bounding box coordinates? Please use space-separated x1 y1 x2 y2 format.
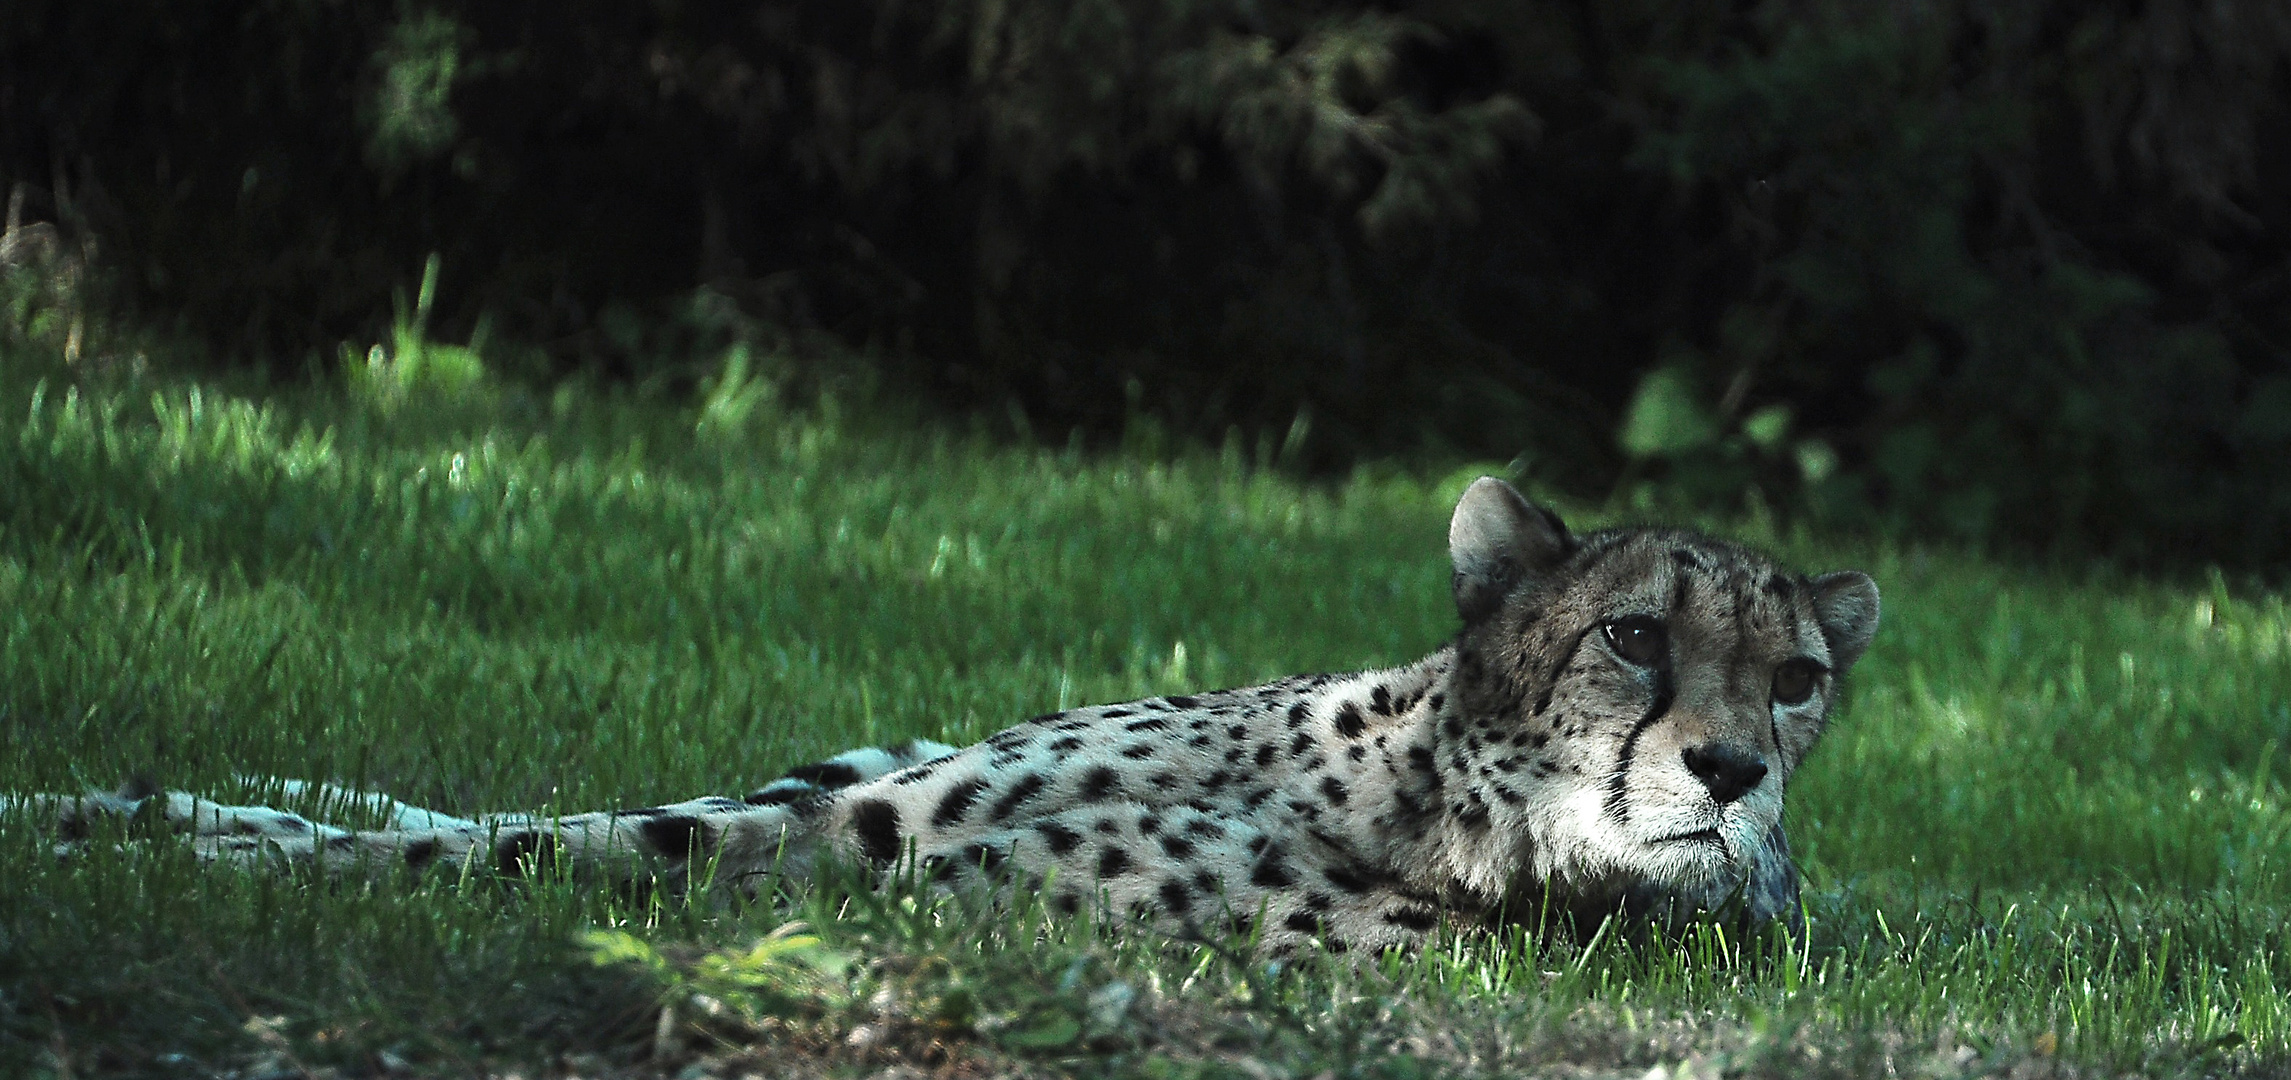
0 0 2291 569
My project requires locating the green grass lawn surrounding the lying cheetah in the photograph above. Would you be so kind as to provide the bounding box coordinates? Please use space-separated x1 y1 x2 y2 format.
0 339 2291 1078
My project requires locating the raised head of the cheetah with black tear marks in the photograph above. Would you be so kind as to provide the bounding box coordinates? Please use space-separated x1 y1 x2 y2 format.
1439 477 1879 915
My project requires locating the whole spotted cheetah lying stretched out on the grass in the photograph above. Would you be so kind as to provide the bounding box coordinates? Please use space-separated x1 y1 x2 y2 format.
18 477 1879 952
